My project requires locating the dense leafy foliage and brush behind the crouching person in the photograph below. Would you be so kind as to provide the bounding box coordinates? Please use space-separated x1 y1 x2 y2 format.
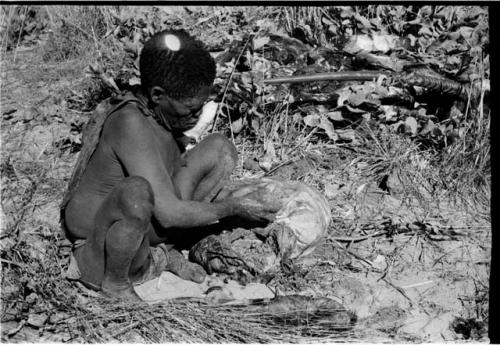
4 5 490 218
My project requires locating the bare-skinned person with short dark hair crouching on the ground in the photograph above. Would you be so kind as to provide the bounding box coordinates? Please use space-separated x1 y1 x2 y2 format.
61 31 277 301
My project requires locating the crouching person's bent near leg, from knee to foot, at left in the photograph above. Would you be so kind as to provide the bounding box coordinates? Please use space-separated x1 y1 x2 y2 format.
75 177 154 301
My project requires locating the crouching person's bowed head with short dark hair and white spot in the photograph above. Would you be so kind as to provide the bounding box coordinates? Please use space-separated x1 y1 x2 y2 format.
140 30 215 130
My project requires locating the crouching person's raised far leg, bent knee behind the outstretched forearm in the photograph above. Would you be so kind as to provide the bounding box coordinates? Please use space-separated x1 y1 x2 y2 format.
173 134 238 202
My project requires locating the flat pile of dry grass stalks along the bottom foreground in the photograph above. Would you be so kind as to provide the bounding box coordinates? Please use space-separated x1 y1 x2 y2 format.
51 301 355 343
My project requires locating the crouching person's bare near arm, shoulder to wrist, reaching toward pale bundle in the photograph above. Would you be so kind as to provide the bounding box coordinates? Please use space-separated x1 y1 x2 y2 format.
102 107 238 228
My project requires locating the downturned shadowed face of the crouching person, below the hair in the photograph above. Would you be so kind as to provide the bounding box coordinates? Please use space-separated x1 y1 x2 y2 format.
158 86 210 132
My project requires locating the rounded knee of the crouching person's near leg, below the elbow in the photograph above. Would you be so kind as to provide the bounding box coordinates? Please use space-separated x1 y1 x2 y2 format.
118 176 154 224
